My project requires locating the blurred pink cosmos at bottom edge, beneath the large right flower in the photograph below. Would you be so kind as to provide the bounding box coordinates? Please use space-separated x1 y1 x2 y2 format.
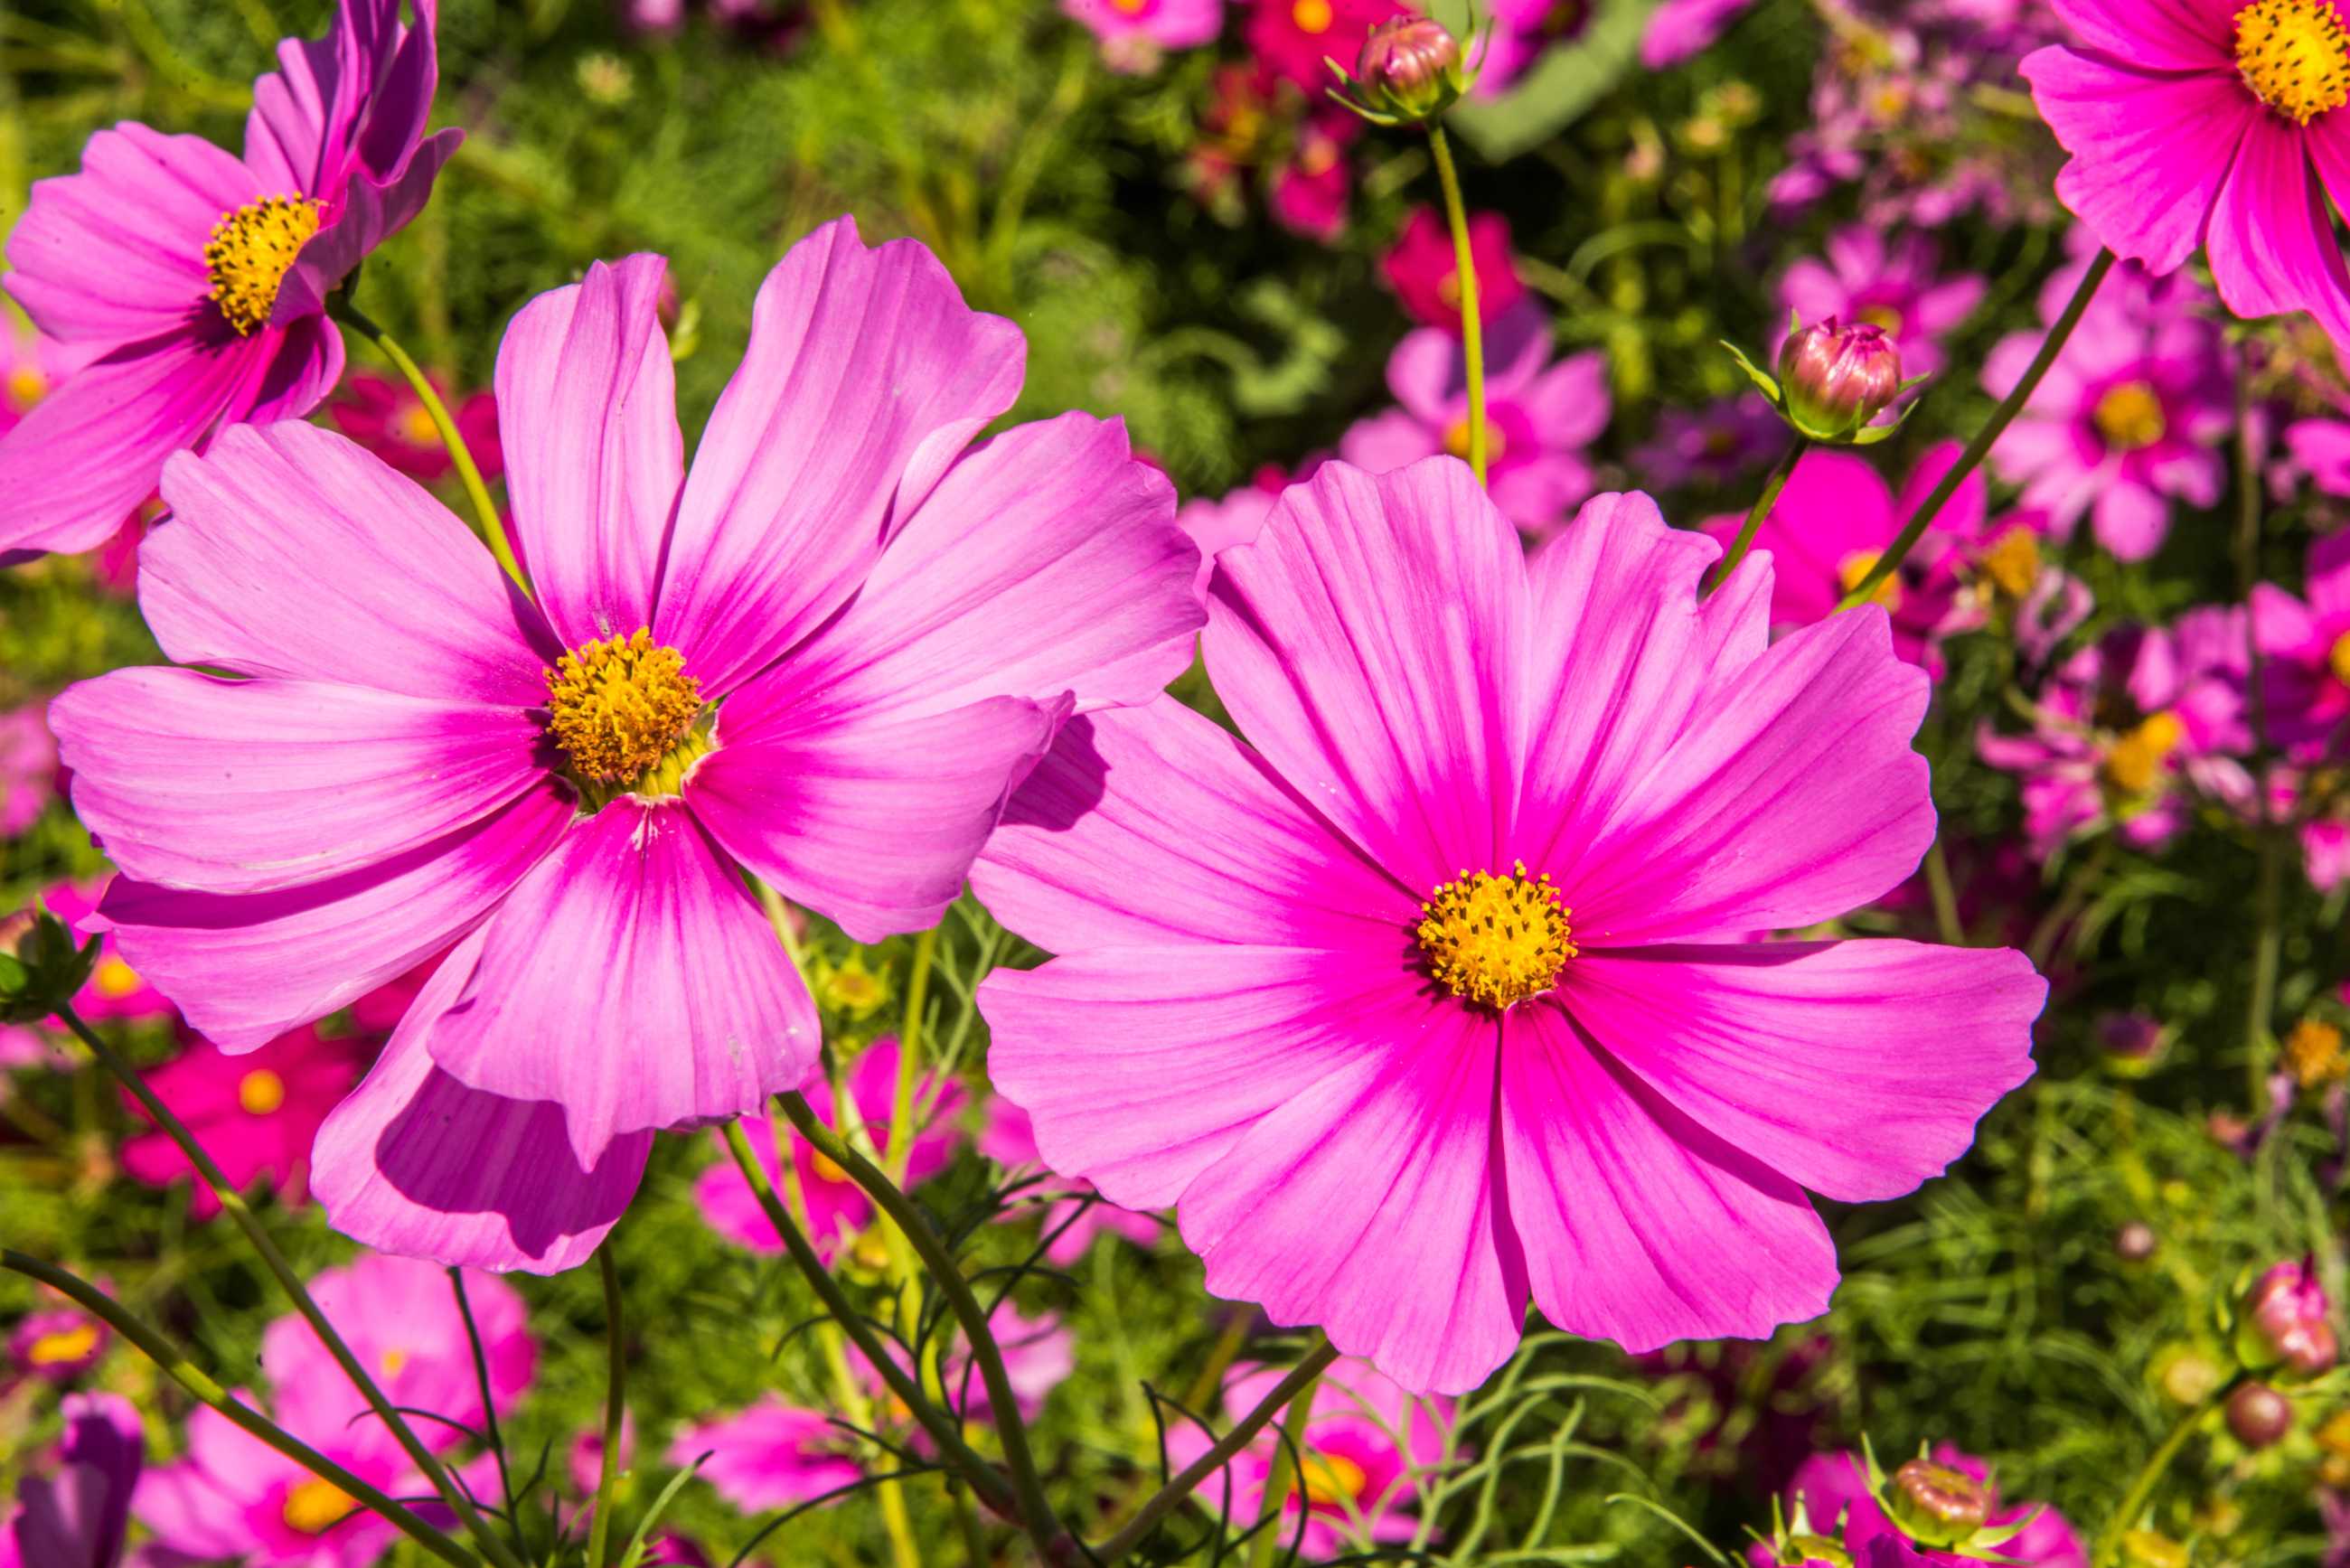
1168 1357 1452 1561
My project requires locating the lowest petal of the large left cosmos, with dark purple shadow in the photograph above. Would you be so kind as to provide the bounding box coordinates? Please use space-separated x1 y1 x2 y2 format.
310 934 653 1274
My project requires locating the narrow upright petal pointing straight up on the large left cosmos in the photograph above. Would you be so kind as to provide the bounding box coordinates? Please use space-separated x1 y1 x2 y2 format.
498 257 682 648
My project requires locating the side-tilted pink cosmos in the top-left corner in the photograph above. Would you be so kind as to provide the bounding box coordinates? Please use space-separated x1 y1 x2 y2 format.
0 0 463 555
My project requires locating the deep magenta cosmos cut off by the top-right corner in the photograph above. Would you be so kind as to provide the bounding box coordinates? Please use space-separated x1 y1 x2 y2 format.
2024 0 2350 345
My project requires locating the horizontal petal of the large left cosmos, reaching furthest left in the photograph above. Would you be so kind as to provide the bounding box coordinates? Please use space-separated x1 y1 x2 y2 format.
50 668 545 893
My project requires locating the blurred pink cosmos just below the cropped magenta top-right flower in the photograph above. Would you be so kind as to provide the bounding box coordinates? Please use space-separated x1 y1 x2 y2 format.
1983 267 2235 562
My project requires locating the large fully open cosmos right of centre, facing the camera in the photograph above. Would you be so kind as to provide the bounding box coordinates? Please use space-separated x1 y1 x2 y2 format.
973 458 2047 1392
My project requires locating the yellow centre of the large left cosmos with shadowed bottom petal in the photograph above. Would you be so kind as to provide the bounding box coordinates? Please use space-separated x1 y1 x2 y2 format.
548 628 710 794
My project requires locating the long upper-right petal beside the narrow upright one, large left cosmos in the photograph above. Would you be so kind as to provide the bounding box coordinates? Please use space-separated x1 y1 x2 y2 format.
653 219 1027 696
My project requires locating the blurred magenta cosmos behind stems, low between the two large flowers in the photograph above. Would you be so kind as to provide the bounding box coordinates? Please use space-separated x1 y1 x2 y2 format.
693 1037 964 1263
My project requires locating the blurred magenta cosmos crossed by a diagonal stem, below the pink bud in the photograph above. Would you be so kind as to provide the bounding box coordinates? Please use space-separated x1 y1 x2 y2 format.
1706 442 1988 670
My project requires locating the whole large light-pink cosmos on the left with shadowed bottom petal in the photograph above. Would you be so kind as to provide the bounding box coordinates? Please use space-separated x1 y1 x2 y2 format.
52 219 1203 1270
